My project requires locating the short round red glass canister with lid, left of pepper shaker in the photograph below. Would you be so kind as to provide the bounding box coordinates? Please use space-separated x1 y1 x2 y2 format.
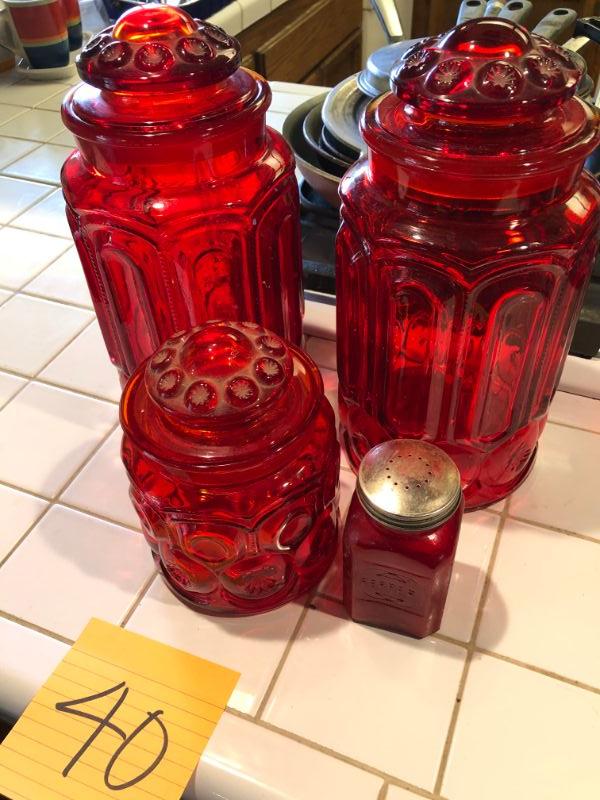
121 322 340 615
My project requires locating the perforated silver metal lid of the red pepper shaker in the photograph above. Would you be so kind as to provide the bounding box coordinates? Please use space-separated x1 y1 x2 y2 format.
357 439 461 530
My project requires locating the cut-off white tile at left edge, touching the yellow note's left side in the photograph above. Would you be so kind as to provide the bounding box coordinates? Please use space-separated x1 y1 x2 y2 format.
0 617 69 719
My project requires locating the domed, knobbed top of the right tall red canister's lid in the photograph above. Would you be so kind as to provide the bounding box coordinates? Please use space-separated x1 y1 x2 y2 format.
392 17 581 122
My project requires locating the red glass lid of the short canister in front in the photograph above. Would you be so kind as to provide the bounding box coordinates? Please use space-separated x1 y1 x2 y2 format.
121 321 323 464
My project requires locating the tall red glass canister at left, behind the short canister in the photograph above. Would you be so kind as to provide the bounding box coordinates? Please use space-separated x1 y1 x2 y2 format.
62 5 302 378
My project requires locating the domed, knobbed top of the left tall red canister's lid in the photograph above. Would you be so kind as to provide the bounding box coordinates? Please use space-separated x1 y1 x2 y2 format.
77 5 240 91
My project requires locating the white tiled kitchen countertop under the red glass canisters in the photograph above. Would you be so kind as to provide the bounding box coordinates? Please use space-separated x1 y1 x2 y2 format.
0 69 600 800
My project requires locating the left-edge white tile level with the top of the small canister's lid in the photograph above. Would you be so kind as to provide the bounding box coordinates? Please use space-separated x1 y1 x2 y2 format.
0 295 93 375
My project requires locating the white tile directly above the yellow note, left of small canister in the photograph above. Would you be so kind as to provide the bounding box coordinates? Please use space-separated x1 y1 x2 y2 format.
0 506 154 639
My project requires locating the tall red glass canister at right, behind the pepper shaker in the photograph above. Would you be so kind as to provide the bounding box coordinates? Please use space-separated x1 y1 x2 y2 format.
337 19 600 508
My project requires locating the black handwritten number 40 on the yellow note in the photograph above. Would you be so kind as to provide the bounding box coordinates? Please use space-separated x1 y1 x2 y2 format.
56 681 169 791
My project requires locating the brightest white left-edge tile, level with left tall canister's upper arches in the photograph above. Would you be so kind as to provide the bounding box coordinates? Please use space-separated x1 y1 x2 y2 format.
0 223 68 289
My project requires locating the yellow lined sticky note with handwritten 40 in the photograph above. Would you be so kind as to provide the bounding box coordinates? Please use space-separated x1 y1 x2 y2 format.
0 619 239 800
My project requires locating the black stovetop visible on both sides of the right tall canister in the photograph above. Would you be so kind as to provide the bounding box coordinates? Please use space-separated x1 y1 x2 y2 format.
300 181 600 358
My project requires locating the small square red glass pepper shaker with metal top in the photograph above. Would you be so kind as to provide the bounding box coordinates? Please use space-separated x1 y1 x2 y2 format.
343 439 464 639
